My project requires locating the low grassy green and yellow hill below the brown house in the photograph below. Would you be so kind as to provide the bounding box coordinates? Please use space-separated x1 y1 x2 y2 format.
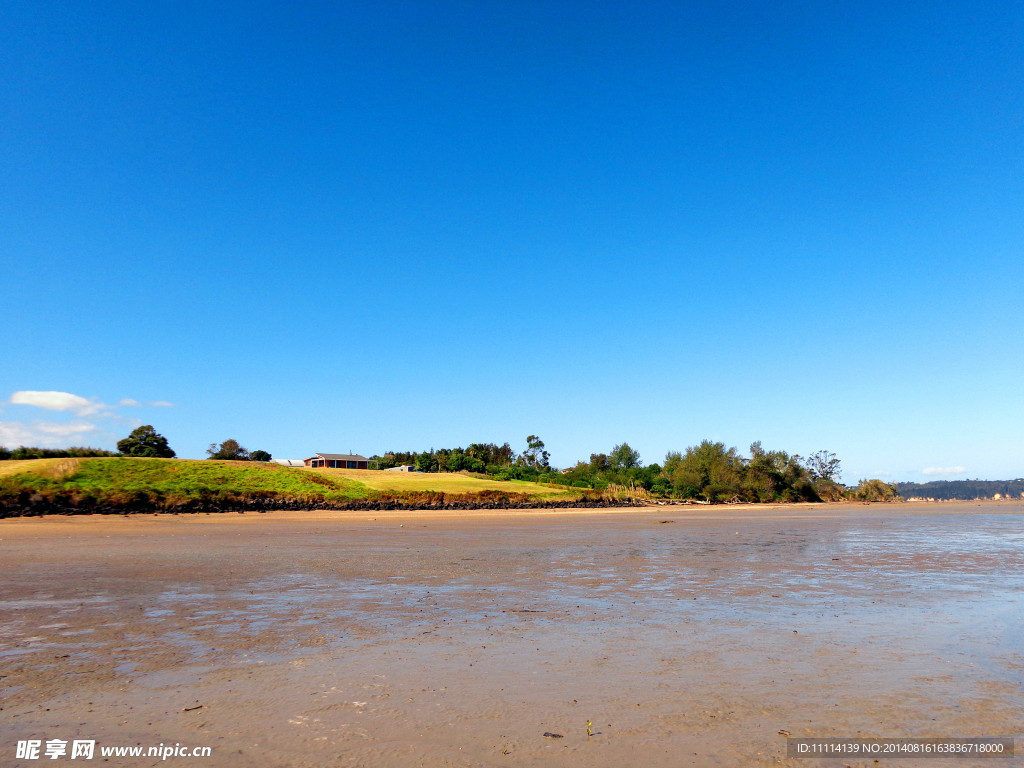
0 457 600 517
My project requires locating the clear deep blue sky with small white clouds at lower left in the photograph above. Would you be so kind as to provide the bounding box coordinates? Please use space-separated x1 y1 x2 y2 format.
0 0 1024 482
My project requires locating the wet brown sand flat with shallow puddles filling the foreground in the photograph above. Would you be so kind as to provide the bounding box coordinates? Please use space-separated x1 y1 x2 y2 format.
0 503 1024 768
